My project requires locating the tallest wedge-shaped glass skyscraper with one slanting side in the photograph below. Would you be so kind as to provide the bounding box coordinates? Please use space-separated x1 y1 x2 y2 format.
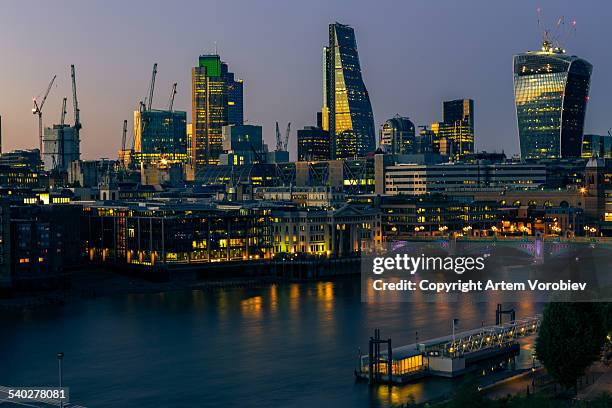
322 23 376 159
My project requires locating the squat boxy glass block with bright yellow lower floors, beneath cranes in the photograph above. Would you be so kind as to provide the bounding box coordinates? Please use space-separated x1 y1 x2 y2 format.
133 109 187 167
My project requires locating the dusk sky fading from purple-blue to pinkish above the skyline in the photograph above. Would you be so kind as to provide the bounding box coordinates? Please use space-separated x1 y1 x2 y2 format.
0 0 612 159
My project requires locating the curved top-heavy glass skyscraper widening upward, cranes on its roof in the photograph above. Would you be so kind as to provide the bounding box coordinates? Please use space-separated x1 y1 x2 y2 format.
514 36 593 160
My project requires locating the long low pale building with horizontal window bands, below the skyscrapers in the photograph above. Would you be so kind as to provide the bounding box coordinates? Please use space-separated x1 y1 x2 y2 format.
376 163 546 195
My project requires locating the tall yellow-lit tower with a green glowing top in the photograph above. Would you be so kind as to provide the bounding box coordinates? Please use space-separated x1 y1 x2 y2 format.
191 54 243 167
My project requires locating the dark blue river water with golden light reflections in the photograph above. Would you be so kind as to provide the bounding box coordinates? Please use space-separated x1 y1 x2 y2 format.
0 277 542 407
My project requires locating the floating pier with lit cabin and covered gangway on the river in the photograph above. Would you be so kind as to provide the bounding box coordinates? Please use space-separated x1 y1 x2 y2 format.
355 306 541 384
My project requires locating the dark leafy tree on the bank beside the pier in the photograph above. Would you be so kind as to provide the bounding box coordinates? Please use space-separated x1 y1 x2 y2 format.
536 303 605 389
